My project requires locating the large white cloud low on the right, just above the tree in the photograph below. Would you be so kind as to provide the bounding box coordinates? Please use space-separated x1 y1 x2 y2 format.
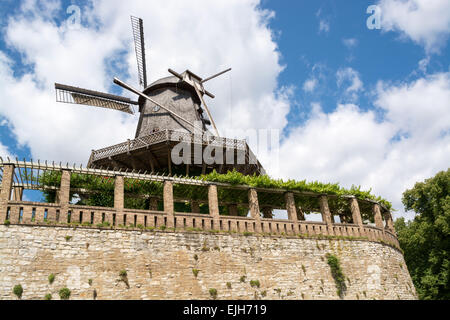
279 73 450 218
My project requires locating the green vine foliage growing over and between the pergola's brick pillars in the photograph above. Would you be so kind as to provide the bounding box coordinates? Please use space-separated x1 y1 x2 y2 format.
39 170 392 214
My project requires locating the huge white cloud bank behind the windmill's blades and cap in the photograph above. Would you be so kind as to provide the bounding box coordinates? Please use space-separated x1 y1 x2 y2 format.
0 0 292 163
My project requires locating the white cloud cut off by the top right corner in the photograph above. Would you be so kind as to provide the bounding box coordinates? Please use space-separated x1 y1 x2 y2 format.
379 0 450 53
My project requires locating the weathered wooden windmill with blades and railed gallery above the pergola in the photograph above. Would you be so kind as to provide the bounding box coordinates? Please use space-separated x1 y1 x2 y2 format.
55 17 265 175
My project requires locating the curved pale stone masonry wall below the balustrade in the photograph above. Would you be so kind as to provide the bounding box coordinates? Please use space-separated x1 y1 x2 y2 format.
0 225 417 299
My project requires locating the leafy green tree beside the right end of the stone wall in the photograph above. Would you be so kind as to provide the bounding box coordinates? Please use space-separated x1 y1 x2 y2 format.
395 169 450 300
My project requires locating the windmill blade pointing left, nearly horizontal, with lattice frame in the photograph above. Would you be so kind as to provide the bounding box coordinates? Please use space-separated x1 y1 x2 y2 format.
55 83 139 114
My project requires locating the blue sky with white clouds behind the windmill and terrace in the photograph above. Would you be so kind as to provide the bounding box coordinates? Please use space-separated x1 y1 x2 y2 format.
0 0 450 218
